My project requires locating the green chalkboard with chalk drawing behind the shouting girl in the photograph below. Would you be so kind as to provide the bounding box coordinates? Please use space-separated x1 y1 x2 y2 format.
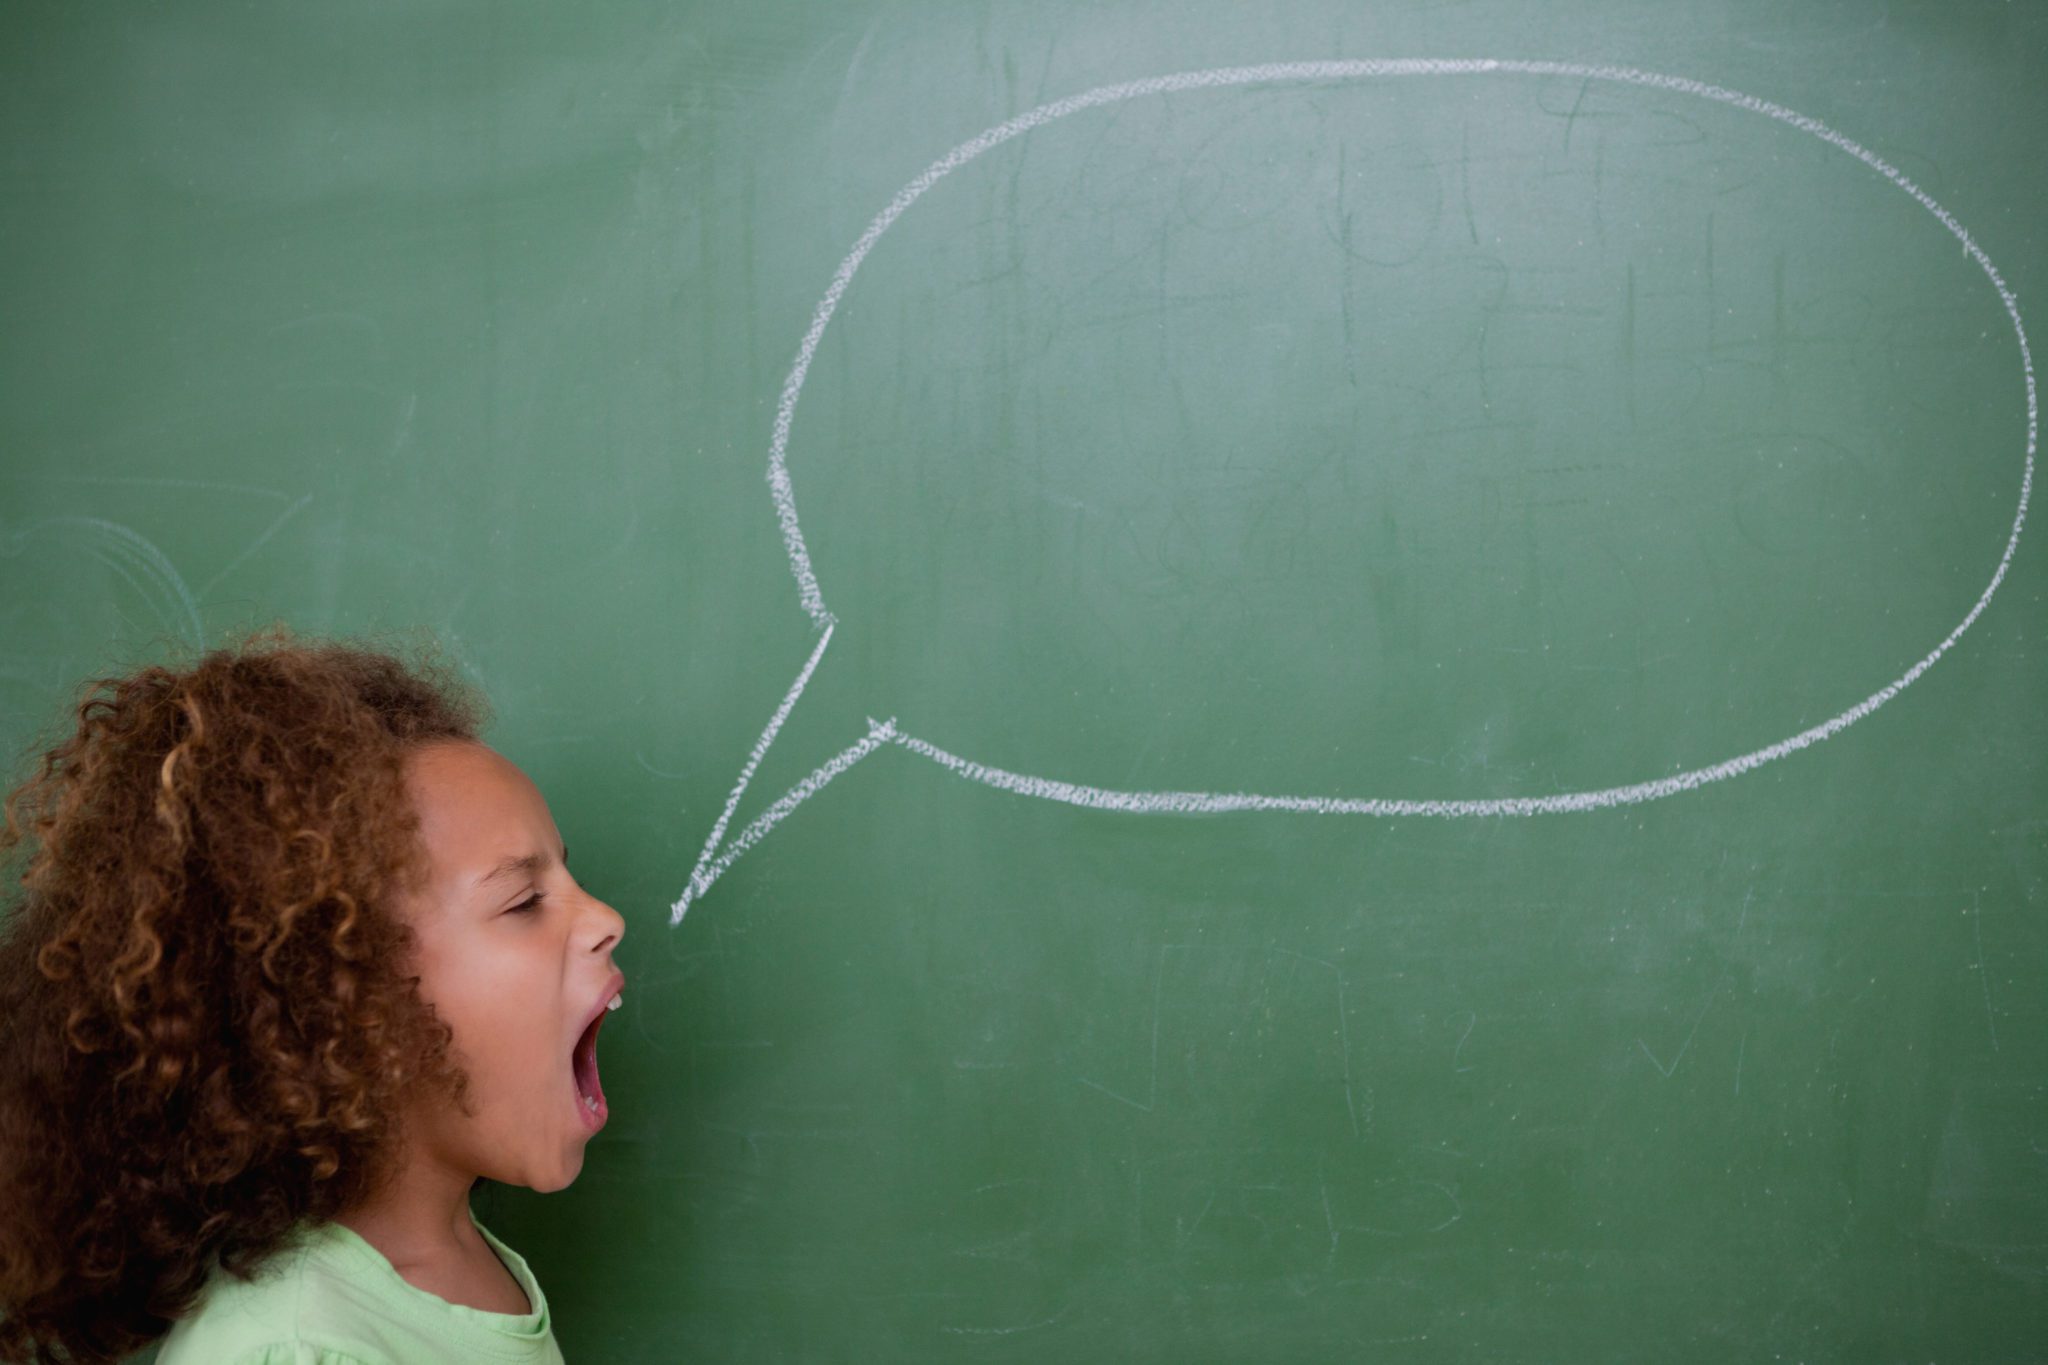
0 0 2048 1361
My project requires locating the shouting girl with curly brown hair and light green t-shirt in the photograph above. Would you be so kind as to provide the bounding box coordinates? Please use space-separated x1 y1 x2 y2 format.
0 628 625 1365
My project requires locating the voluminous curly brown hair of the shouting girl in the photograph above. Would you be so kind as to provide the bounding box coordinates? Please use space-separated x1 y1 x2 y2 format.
0 626 487 1365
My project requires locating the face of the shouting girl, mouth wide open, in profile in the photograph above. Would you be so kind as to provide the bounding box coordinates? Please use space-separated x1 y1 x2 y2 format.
399 743 627 1191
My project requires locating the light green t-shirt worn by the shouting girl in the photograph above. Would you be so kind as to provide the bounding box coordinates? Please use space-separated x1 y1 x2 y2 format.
156 1212 561 1365
